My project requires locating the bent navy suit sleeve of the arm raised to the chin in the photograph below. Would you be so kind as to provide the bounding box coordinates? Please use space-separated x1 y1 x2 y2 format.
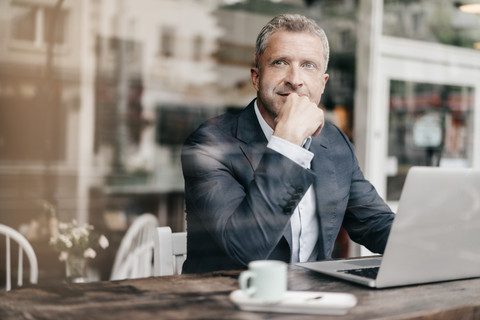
182 128 315 265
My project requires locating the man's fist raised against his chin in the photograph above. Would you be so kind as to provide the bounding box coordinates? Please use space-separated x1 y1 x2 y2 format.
273 93 325 146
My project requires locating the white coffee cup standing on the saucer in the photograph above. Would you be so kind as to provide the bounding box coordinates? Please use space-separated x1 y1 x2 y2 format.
238 260 287 303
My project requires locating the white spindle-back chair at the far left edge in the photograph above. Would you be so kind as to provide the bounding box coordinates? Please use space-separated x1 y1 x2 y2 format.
0 224 38 291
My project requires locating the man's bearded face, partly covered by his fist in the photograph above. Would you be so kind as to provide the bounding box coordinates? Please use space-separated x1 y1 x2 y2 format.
250 30 328 128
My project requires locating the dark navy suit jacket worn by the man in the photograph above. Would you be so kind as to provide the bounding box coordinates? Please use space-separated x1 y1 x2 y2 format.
182 102 394 273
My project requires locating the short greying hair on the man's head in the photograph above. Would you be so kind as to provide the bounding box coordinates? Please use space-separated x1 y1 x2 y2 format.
255 14 330 72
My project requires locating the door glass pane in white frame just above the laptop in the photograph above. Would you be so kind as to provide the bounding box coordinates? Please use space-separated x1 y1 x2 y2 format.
387 80 474 201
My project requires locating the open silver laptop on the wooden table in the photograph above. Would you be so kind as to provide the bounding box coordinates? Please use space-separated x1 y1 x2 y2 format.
297 167 480 288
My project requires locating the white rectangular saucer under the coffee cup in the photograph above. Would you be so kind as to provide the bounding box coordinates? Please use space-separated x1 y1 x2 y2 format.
230 290 357 315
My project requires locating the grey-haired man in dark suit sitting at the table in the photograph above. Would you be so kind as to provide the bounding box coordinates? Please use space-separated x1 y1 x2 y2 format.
182 15 394 273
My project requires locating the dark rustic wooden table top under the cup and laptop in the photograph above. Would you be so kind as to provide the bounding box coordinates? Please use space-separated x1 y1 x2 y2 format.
0 266 480 320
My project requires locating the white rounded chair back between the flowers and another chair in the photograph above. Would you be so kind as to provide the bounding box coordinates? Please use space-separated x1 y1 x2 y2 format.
110 213 158 280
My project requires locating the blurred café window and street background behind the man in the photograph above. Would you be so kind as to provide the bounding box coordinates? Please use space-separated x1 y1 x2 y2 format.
0 0 480 282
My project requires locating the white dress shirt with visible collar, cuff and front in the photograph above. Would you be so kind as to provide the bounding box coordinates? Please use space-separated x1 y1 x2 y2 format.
255 101 319 262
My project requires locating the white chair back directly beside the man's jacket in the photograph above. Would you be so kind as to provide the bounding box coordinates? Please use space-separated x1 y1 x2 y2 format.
153 227 187 276
